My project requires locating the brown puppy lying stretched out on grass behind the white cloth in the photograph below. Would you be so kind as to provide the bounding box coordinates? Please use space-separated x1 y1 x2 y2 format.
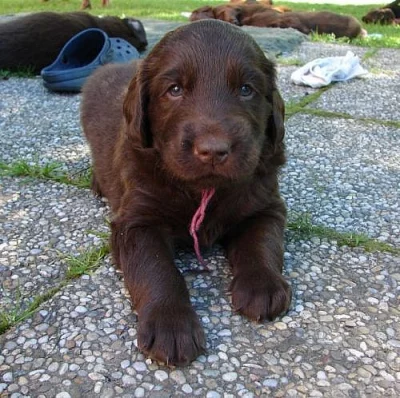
241 10 364 38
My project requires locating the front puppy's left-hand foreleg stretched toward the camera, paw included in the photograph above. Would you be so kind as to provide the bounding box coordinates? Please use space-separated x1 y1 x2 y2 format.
111 220 205 366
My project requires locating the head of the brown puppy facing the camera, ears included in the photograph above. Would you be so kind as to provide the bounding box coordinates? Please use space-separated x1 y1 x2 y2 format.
124 20 284 188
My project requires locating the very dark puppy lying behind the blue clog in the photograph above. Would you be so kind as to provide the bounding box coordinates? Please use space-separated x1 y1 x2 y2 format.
0 12 147 73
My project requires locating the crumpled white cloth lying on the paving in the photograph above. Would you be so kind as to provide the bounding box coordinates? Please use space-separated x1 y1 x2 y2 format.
290 51 368 88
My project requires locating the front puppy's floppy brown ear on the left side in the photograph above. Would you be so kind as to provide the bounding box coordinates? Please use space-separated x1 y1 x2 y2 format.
123 68 152 148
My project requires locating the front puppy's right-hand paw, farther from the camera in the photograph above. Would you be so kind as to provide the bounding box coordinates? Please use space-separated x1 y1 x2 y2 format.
231 270 291 321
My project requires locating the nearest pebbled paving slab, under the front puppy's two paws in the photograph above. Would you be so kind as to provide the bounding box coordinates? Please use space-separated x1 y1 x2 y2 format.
0 241 400 398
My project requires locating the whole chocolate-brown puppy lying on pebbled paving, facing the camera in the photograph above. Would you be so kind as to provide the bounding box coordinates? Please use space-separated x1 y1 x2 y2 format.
81 20 291 365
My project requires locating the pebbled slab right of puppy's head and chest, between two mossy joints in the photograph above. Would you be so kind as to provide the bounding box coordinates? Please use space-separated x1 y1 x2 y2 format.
281 112 400 246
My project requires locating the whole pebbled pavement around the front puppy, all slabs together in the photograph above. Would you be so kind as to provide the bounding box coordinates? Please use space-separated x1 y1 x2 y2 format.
0 21 400 398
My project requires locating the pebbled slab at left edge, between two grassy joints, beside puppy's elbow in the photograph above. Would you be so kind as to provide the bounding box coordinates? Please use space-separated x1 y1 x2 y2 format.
0 178 108 310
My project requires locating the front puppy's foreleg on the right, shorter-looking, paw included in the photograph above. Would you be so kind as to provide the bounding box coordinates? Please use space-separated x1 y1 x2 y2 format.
225 204 291 321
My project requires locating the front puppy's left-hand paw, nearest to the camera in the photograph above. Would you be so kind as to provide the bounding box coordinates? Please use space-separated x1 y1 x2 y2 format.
138 305 206 366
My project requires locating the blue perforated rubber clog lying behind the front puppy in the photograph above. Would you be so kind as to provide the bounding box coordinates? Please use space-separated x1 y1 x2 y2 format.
40 28 139 92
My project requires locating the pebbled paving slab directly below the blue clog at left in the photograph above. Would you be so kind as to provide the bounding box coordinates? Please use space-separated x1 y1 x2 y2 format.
0 77 90 171
